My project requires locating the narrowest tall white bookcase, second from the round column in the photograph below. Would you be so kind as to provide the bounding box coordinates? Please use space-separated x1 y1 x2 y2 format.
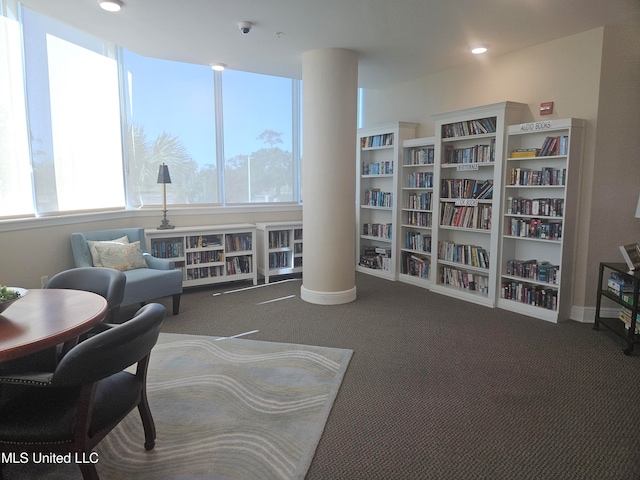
398 137 437 288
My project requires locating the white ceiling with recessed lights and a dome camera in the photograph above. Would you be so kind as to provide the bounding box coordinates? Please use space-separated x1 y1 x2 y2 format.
22 0 640 88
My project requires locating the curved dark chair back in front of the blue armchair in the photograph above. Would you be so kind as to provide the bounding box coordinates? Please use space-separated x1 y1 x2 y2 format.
44 267 127 310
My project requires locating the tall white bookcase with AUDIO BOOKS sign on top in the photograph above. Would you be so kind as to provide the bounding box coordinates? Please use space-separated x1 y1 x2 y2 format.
498 118 584 322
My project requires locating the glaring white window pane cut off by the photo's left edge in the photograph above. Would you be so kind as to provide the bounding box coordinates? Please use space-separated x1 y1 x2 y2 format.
0 3 34 217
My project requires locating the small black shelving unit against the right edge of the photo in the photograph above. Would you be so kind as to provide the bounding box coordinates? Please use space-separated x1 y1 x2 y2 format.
593 262 640 355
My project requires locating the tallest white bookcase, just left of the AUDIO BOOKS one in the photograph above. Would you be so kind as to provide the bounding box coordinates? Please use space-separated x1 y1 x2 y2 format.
430 102 526 307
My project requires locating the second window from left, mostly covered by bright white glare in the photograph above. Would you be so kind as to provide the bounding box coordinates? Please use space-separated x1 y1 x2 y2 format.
23 8 124 213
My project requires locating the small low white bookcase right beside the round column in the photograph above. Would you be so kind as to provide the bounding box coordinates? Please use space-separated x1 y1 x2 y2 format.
256 221 302 283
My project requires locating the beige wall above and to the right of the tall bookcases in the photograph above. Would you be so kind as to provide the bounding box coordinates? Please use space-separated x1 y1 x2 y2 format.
363 27 640 321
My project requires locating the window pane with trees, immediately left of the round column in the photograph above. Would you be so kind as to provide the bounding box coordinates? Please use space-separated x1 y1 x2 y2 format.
222 70 299 203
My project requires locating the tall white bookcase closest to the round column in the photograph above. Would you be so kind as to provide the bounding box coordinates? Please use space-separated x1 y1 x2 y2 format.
356 122 416 280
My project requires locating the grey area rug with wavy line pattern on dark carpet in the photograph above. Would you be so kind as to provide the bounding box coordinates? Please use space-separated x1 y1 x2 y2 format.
5 334 353 480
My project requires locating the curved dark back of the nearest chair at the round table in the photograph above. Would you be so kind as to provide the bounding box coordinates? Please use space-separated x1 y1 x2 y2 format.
50 303 166 387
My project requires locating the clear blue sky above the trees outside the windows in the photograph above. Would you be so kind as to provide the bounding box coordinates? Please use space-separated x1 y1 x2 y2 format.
124 50 292 165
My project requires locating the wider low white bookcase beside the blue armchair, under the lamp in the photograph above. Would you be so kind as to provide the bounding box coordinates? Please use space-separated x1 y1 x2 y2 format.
145 224 258 287
